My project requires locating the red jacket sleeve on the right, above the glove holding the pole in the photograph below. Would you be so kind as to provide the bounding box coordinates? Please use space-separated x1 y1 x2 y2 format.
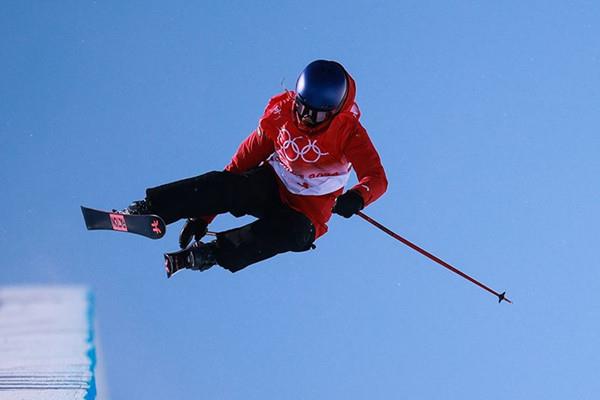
344 126 388 206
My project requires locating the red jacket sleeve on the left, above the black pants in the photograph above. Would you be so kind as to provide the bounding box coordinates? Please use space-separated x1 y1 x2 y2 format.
225 128 275 174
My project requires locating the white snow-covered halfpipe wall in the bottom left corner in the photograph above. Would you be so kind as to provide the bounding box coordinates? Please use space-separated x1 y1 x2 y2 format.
0 286 97 400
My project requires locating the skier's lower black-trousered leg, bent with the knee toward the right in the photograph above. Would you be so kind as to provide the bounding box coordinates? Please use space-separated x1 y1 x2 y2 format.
214 206 315 272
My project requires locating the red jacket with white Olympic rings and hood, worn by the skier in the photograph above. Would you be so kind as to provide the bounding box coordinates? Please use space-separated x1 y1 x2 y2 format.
225 72 387 237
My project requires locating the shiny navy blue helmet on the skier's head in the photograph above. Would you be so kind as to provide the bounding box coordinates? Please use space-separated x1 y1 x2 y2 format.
295 60 348 126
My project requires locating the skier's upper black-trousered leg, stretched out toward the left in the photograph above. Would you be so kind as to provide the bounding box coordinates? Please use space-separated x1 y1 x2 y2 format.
146 165 279 224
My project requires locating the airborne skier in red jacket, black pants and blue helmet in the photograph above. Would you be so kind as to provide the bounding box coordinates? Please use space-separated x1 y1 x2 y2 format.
126 60 387 272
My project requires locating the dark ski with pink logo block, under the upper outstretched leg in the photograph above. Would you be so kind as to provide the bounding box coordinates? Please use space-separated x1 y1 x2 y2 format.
81 206 167 239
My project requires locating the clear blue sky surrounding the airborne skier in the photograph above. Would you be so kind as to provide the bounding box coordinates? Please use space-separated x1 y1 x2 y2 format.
0 0 600 400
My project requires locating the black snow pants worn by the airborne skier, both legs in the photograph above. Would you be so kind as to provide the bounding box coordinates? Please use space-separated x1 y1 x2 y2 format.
146 165 315 272
